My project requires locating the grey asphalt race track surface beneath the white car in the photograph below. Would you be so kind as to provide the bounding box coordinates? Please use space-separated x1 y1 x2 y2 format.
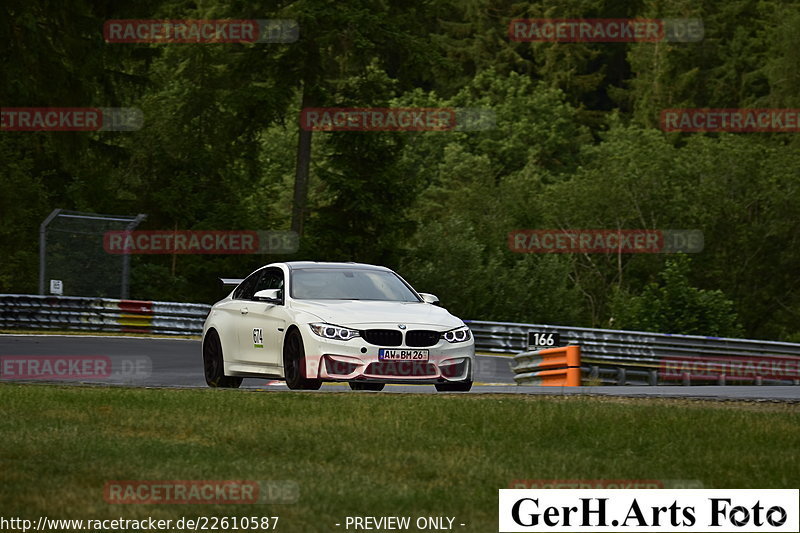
0 334 800 401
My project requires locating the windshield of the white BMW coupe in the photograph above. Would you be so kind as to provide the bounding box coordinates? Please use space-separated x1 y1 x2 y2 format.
291 268 420 302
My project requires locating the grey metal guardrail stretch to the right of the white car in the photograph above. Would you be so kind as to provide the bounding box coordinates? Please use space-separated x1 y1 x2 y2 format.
466 320 800 385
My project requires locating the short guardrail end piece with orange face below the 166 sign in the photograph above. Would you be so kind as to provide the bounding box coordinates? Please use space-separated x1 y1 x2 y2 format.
511 346 581 387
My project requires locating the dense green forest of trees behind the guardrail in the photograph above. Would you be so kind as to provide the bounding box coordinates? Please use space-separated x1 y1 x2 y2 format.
0 0 800 341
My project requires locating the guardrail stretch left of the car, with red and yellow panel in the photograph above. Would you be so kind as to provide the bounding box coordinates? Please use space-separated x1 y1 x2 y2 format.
0 294 211 335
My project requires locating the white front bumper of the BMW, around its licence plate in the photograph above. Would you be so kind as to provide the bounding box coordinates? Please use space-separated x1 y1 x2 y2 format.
303 331 475 383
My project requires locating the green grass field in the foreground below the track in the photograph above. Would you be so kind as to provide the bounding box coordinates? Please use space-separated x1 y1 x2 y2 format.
0 383 800 532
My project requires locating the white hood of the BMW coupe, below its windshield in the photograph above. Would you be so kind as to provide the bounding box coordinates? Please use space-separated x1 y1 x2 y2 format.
291 300 462 330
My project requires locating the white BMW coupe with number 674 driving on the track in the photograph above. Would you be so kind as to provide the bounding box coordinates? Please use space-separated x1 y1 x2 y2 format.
203 262 475 391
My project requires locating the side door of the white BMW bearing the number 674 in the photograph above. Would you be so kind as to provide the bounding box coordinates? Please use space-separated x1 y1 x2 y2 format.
239 267 289 367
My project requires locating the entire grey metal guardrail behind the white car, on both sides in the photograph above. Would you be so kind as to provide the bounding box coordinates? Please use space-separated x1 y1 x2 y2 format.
0 294 800 385
